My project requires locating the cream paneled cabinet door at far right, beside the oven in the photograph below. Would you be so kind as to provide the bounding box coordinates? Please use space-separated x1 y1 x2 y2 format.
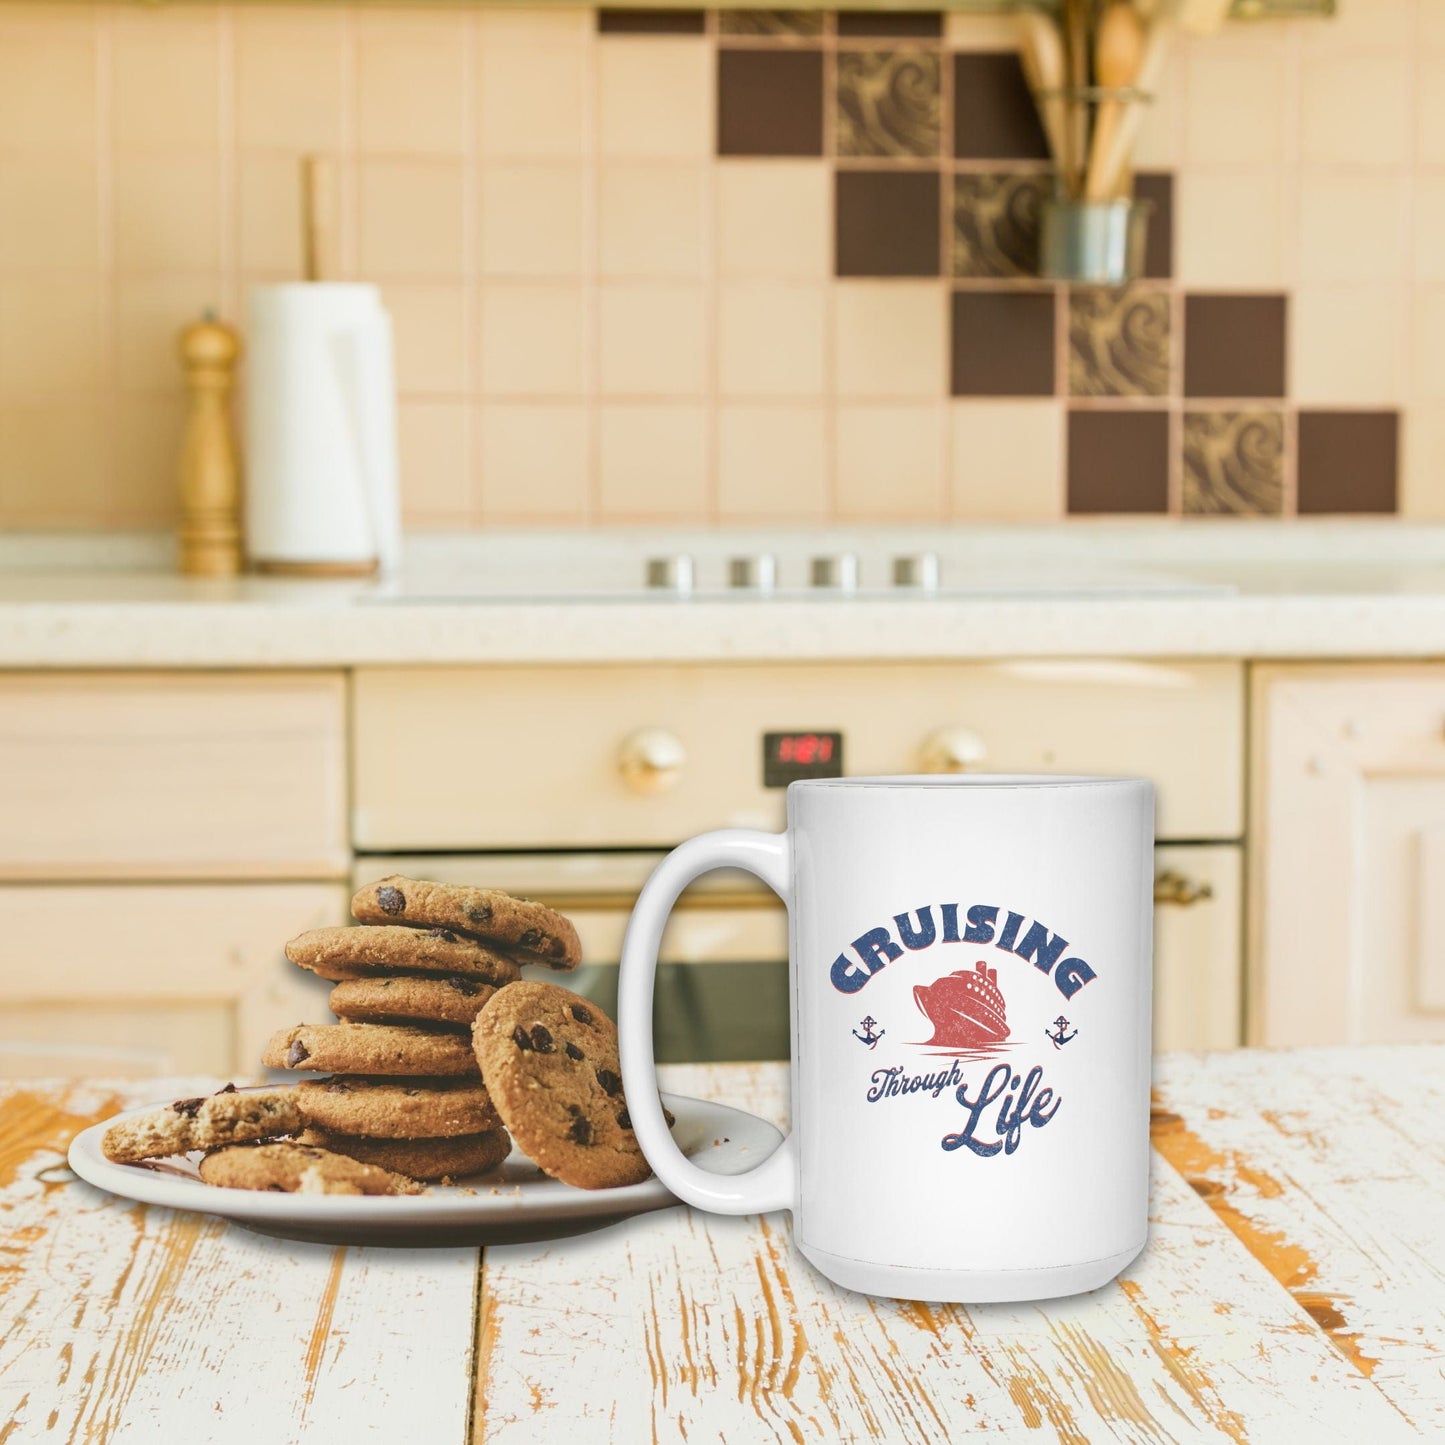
1247 665 1445 1045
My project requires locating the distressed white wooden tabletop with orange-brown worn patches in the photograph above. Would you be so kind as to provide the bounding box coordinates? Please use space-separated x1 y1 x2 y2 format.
0 1046 1445 1445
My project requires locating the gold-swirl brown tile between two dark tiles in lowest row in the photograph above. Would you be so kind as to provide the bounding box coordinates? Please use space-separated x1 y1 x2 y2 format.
1183 412 1285 517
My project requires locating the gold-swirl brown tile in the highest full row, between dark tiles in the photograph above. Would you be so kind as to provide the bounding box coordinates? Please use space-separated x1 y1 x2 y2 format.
835 49 944 158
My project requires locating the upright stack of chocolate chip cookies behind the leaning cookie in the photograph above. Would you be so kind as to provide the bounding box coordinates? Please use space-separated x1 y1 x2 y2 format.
263 877 582 1179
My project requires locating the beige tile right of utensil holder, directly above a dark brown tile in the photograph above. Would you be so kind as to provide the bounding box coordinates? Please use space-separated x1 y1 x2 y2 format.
1175 171 1285 288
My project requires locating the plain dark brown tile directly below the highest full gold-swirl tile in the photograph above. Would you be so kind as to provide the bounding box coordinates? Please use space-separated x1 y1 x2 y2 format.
834 171 941 276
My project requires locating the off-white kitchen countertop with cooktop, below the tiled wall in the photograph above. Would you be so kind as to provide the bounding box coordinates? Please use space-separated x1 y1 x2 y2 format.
8 522 1445 668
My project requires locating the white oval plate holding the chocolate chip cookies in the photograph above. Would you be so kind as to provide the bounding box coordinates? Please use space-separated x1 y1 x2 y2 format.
69 1094 783 1244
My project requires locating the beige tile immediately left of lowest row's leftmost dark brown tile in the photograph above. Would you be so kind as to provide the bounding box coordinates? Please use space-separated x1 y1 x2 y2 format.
948 400 1065 522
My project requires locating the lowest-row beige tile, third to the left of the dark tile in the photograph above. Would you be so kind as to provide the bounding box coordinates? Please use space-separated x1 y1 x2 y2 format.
718 406 828 522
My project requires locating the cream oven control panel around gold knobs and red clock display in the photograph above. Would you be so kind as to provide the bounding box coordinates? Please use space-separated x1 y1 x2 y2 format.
353 660 1244 850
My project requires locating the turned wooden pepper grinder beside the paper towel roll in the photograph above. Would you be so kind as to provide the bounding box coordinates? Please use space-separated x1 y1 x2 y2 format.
179 312 241 577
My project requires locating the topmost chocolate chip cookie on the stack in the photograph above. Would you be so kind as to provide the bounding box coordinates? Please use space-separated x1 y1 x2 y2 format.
351 874 582 968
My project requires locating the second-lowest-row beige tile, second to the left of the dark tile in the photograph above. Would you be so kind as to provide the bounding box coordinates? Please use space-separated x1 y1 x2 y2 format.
718 282 828 396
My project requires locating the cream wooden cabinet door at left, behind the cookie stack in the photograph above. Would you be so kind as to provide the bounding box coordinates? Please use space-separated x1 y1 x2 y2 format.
0 883 348 1078
